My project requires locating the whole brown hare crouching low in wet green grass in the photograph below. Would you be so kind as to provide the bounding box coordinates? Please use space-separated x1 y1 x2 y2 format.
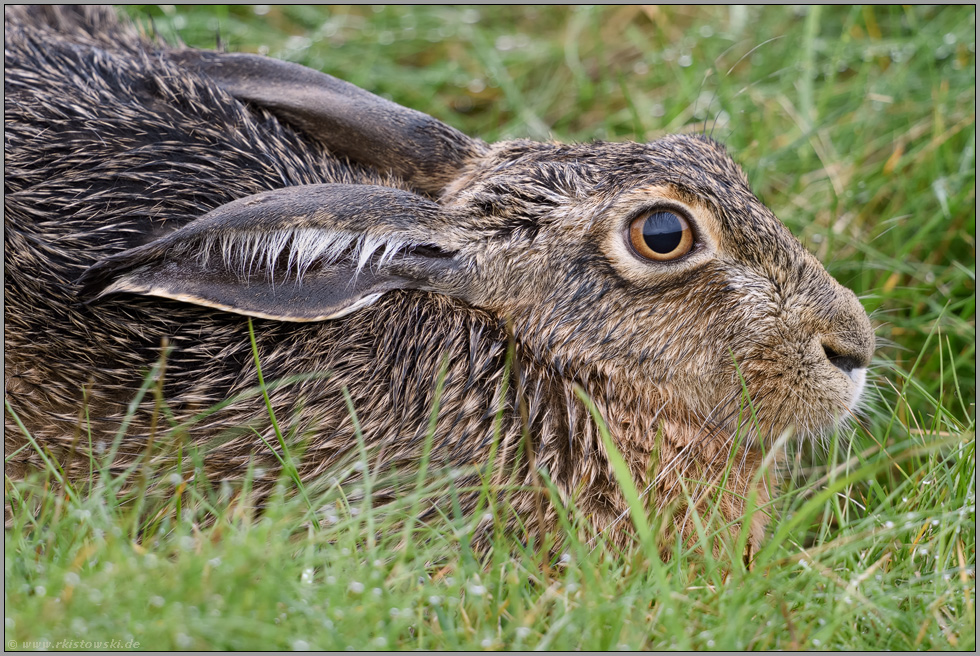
4 8 874 548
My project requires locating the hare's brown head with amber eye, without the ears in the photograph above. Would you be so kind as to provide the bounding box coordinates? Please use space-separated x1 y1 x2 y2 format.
441 136 874 442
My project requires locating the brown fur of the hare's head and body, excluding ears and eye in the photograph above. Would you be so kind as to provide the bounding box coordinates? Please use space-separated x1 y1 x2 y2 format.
4 10 873 548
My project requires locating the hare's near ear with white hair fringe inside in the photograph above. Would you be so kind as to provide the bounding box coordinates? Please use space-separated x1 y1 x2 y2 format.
79 184 465 321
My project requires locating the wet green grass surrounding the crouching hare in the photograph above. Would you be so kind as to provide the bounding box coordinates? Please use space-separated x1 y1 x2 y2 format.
4 6 976 651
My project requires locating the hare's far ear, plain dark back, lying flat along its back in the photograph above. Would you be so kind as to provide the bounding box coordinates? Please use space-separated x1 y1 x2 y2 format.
169 50 486 196
